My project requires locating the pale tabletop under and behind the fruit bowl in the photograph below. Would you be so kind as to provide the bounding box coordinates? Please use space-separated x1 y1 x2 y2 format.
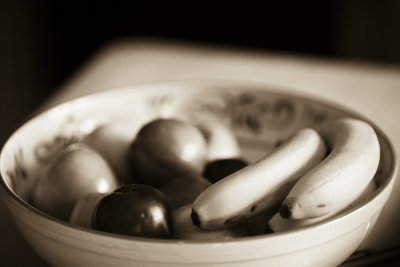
0 39 400 266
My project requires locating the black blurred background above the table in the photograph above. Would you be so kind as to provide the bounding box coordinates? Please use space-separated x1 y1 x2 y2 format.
0 0 400 145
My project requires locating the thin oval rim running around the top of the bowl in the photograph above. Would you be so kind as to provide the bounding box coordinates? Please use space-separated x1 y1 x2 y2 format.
0 79 398 245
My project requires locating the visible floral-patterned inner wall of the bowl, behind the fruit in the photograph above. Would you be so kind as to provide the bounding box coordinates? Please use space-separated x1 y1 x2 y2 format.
0 82 395 226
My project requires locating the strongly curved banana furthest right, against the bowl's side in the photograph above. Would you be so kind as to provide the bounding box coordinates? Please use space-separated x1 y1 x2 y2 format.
279 118 380 219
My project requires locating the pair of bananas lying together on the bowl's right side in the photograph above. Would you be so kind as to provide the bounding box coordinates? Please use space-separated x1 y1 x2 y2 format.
191 118 380 230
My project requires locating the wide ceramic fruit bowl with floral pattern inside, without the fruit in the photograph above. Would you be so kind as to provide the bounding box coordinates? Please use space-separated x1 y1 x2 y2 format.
0 81 396 267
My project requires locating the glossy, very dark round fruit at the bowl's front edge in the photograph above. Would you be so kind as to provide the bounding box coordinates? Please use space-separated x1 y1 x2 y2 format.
92 184 172 238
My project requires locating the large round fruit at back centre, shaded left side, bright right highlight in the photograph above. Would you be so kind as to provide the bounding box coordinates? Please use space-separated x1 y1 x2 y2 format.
129 119 207 186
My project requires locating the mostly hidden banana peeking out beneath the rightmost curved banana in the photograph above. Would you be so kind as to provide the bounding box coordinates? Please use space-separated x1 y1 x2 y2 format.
267 179 376 232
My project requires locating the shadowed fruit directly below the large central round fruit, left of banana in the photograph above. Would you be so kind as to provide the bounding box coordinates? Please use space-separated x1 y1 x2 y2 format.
159 176 211 209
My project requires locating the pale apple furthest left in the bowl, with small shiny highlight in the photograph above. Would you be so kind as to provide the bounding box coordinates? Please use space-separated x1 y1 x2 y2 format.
32 143 118 220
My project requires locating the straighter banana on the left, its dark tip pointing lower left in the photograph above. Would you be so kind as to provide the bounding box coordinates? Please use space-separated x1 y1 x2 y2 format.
191 128 327 230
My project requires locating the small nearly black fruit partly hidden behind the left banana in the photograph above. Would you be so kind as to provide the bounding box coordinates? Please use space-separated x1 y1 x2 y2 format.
203 158 248 183
